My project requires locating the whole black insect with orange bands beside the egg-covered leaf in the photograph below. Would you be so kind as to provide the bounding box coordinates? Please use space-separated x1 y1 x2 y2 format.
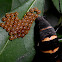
33 16 62 62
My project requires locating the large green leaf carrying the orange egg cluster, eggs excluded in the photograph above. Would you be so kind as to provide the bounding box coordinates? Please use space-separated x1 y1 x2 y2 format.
0 0 44 62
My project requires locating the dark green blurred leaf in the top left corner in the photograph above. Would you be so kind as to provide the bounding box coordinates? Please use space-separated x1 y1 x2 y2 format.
0 0 12 17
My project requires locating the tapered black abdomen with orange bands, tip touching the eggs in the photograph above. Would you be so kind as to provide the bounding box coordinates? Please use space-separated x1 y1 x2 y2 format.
37 16 59 53
